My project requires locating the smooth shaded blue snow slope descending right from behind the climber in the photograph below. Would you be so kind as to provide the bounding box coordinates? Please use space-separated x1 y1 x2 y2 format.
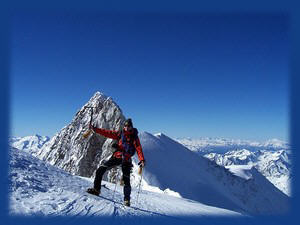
140 132 289 214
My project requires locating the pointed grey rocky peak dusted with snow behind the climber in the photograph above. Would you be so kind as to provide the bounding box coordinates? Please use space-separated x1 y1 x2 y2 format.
34 92 125 177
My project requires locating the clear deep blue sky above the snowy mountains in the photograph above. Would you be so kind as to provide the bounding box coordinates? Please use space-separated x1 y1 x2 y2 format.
10 13 289 141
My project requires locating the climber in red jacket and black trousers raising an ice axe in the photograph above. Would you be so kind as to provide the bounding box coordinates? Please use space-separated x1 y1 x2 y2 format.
87 119 145 206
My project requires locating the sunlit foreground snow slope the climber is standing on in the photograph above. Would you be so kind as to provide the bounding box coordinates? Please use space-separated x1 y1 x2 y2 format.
9 148 241 221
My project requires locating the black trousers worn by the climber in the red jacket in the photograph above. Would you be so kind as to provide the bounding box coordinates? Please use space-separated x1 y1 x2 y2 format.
94 157 132 200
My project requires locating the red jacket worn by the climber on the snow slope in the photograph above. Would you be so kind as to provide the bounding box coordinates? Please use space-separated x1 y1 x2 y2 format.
94 127 145 161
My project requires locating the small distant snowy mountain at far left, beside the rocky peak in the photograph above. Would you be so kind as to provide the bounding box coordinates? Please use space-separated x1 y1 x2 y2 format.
9 134 50 153
